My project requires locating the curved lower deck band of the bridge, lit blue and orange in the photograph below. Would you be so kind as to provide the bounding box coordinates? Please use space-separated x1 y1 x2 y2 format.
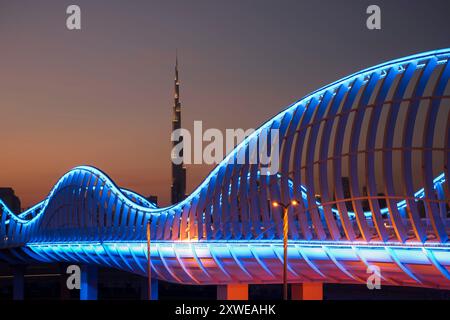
3 241 450 289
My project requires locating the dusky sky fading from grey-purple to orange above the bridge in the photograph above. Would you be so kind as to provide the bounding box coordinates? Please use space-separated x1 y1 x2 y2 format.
0 0 450 207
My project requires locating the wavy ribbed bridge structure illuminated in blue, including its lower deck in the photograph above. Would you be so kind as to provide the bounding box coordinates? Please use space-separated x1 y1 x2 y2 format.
0 49 450 289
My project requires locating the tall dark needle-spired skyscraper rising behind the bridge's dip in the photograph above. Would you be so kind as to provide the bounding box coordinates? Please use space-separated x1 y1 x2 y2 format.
171 56 186 204
